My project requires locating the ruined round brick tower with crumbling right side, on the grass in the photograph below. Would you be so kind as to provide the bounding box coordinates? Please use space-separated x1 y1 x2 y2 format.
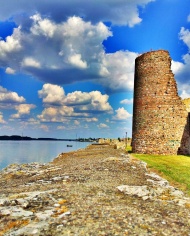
132 50 190 155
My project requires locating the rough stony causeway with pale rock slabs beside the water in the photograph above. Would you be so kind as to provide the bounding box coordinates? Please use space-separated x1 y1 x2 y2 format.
0 144 190 236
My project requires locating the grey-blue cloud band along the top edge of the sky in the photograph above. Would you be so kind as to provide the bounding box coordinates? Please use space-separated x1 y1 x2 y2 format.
0 0 154 26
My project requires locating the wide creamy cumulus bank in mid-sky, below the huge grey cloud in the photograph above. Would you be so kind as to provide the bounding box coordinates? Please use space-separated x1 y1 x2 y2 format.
38 84 113 122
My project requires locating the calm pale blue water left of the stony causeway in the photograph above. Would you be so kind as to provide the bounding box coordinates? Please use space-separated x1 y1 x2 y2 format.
0 141 89 170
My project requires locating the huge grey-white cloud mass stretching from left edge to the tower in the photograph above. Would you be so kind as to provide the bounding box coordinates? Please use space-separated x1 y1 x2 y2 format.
0 14 138 92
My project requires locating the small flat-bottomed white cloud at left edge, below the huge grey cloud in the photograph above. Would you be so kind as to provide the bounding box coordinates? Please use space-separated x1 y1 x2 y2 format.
0 86 25 103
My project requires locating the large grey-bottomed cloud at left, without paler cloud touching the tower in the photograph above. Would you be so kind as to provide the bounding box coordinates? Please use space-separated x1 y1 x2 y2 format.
0 14 112 89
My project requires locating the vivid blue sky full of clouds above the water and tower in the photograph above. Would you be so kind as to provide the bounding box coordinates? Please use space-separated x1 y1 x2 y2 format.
0 0 190 138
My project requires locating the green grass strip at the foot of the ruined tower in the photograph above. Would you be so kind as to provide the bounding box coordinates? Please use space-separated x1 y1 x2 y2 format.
127 147 190 196
